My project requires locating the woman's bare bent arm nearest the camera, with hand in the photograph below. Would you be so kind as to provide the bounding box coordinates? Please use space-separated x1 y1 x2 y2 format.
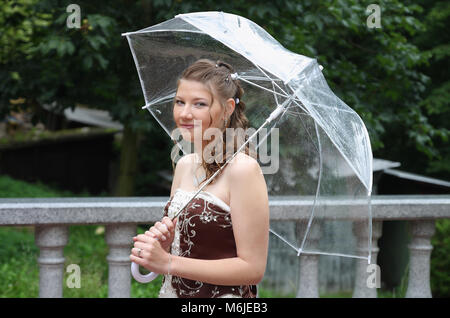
131 155 269 285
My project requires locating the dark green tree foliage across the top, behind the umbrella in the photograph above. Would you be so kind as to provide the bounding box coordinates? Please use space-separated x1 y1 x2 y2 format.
0 0 450 186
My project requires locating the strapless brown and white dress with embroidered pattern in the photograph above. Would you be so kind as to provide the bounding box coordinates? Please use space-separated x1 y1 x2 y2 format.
159 189 257 298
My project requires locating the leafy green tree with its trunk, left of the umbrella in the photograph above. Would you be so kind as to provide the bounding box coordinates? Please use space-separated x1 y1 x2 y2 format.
0 0 157 195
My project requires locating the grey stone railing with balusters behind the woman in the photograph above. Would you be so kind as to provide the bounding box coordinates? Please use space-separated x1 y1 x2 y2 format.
0 195 450 297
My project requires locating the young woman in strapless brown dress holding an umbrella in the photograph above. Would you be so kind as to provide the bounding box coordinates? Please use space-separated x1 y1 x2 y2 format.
130 59 269 298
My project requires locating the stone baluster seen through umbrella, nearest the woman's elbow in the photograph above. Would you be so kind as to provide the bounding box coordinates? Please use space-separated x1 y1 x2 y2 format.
296 220 321 298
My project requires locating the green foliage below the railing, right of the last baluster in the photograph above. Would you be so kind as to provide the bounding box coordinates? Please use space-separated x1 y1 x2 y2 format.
430 219 450 298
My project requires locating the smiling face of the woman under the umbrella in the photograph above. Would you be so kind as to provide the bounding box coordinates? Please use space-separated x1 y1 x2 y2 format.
173 79 224 142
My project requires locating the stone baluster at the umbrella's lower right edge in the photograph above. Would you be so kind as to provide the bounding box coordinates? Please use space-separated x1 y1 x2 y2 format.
353 221 382 298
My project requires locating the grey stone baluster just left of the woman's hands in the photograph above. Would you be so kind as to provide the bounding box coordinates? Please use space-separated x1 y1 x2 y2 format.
106 224 136 298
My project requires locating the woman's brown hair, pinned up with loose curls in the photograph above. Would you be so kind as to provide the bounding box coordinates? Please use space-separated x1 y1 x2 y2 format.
174 59 255 183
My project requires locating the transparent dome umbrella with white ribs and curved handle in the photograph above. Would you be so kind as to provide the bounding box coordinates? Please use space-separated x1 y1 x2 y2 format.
123 12 372 282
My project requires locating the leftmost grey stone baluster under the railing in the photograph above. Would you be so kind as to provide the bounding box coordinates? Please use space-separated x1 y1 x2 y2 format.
35 225 68 298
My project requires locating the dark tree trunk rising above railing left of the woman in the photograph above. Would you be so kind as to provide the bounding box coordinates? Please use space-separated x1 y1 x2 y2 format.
114 123 138 196
